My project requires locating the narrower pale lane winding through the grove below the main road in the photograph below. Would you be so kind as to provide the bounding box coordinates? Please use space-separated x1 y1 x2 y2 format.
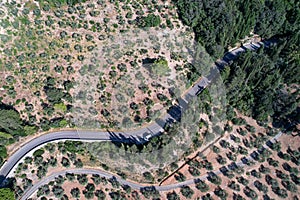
21 132 283 200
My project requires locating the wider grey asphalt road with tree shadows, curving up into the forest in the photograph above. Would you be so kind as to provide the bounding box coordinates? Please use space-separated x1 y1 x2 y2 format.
0 41 272 198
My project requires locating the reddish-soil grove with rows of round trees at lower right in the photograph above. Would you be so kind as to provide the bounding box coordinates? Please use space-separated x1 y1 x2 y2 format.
160 114 300 199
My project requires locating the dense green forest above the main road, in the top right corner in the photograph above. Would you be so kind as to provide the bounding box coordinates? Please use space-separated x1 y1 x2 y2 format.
174 0 300 58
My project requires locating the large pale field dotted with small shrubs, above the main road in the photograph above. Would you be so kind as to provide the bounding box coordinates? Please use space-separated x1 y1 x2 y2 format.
0 0 199 130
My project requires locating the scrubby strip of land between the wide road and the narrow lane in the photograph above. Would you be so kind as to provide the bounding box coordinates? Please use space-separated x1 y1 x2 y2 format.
10 85 223 195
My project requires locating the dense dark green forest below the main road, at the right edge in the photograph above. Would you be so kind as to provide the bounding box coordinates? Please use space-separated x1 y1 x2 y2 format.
222 34 300 128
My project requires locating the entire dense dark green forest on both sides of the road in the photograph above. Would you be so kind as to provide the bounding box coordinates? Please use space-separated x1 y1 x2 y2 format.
174 0 300 128
